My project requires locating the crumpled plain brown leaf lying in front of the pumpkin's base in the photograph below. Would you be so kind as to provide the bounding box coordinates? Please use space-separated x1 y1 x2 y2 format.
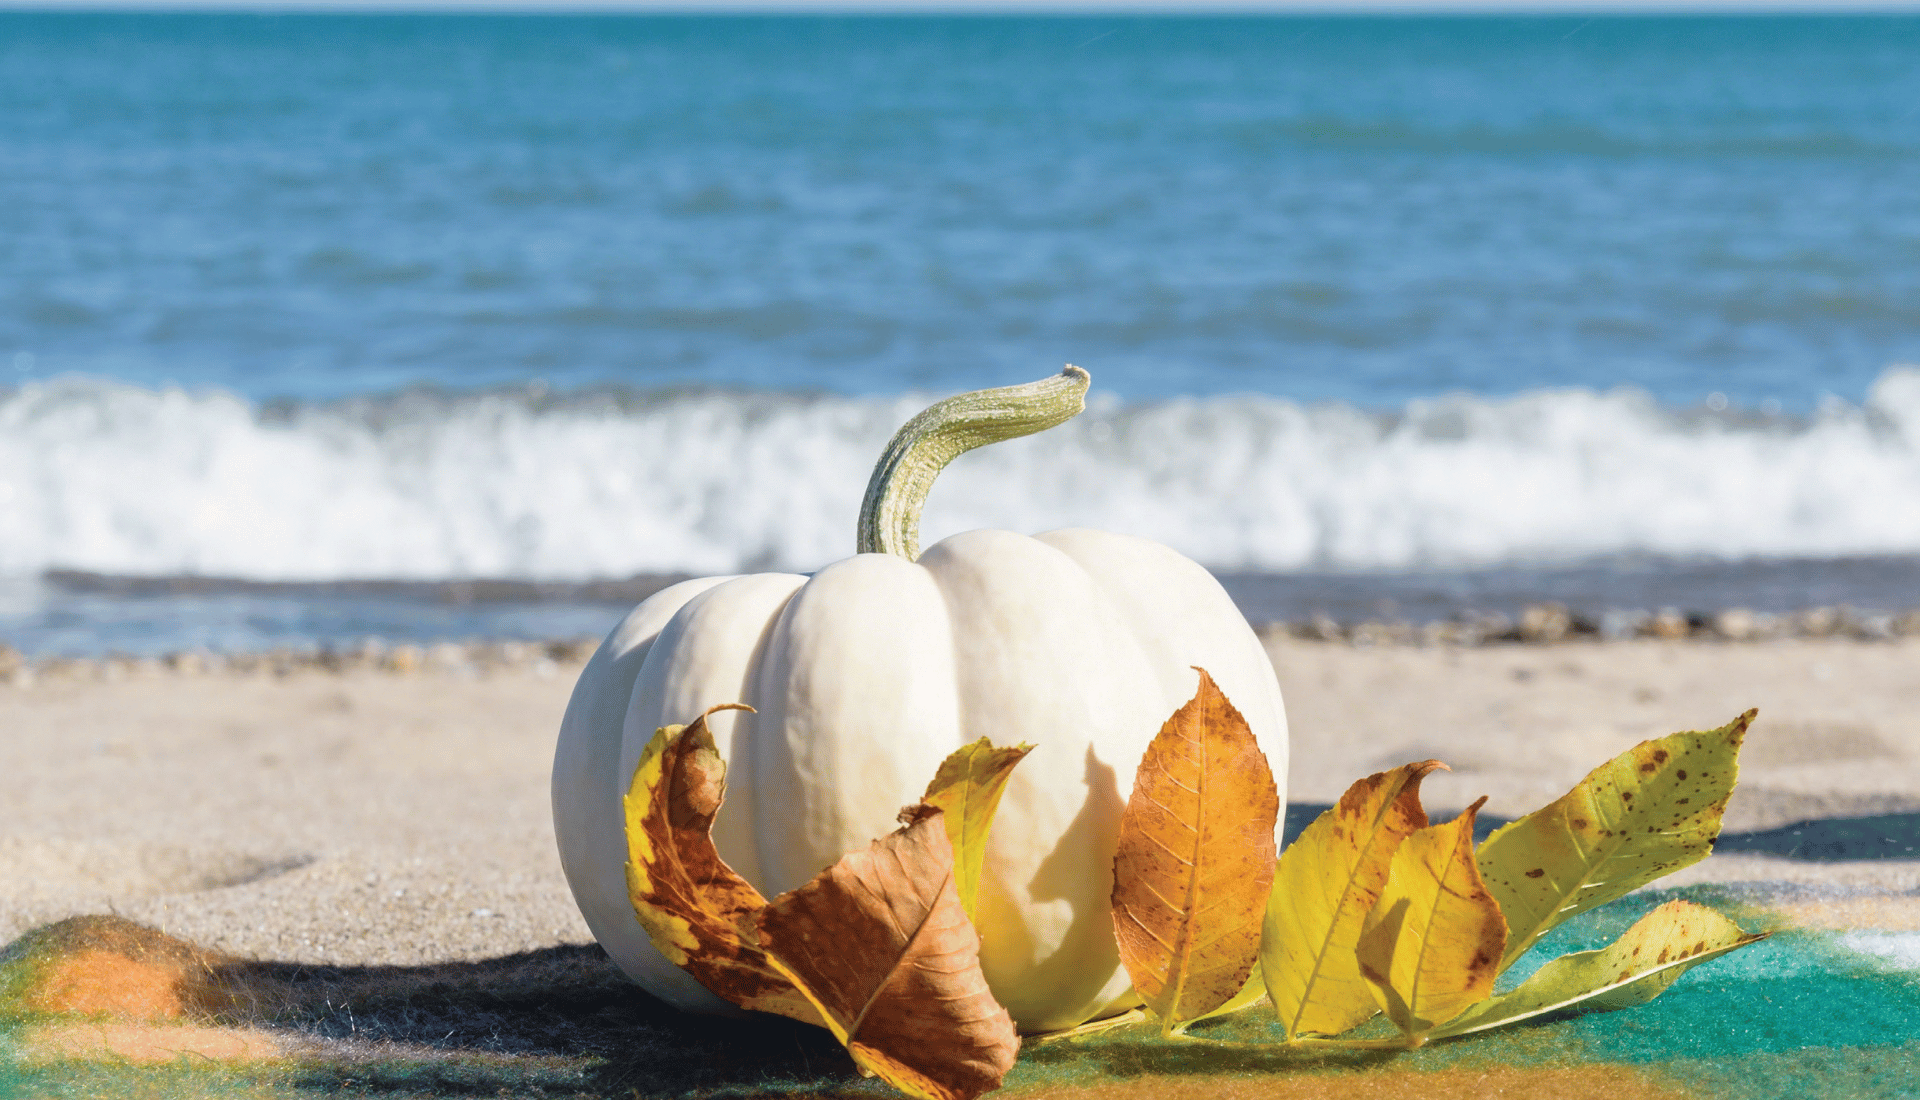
758 804 1020 1100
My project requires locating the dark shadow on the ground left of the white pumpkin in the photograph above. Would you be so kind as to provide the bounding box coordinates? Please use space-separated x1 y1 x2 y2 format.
211 945 885 1096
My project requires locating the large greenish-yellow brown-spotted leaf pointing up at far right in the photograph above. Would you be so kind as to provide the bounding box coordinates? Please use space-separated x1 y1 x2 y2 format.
1478 710 1757 969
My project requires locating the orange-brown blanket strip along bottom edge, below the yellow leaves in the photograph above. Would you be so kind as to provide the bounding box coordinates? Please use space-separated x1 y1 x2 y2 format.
1018 1065 1690 1100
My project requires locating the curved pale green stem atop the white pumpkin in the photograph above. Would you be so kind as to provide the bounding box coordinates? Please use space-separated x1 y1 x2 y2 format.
856 365 1091 561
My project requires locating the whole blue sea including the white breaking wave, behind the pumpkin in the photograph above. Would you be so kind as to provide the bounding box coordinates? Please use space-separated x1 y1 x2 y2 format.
0 12 1920 653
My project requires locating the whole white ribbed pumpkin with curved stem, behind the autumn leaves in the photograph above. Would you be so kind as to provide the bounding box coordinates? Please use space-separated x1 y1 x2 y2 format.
553 367 1286 1031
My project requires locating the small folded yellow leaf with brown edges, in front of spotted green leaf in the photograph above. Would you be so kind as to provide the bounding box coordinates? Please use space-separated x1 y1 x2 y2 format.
1357 799 1507 1046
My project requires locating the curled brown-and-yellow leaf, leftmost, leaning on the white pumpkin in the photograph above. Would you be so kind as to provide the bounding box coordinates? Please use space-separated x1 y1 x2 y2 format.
622 705 824 1025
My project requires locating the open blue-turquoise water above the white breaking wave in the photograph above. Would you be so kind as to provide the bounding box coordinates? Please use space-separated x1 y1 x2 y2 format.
0 13 1920 411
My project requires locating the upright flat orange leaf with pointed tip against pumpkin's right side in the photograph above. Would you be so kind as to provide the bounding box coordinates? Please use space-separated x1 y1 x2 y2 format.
1114 670 1281 1033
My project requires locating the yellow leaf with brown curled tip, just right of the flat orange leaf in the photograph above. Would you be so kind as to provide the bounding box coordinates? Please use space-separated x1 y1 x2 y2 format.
1260 760 1446 1040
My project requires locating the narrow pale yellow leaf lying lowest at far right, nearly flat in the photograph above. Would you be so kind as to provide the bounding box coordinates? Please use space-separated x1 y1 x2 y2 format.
1432 900 1768 1039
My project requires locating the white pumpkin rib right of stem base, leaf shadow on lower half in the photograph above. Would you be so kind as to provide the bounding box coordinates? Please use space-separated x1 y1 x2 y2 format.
918 530 1171 1031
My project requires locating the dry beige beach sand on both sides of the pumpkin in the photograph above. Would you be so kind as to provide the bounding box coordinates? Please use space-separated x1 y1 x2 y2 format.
0 639 1920 966
